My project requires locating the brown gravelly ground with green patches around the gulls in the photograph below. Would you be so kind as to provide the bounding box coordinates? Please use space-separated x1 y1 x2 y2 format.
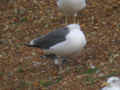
0 0 120 90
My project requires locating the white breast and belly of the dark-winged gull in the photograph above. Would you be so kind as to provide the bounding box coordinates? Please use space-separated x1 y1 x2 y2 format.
46 30 86 56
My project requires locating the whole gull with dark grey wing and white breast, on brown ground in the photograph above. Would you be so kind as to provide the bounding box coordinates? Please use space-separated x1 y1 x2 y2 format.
25 24 87 64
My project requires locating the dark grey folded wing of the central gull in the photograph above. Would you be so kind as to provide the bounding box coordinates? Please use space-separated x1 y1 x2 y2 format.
31 27 69 49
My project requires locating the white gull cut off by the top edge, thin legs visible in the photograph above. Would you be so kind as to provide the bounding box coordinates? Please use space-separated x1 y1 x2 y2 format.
57 0 86 23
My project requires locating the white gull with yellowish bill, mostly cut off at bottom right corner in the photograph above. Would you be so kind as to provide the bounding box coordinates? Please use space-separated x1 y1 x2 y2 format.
101 76 120 90
